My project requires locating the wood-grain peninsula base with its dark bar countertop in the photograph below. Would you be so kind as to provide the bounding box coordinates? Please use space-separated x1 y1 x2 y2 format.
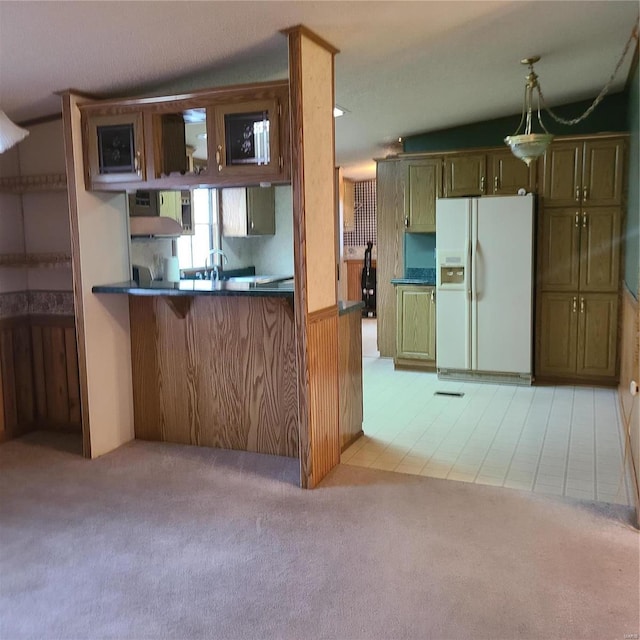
93 280 362 457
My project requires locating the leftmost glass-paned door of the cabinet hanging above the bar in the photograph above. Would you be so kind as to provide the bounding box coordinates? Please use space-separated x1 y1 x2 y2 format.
82 111 146 189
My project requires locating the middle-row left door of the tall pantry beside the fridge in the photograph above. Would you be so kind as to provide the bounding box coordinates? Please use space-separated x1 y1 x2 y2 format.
539 207 582 291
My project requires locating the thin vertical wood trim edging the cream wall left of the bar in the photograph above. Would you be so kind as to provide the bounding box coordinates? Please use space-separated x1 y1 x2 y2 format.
62 91 91 458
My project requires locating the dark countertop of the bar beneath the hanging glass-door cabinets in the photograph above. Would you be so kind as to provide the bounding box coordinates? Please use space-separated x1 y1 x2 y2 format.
91 280 294 299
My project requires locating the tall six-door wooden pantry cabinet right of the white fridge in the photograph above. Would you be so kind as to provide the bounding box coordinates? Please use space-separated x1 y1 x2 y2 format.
536 136 626 383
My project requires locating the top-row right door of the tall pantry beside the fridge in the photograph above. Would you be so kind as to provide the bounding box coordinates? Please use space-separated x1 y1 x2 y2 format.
582 139 624 206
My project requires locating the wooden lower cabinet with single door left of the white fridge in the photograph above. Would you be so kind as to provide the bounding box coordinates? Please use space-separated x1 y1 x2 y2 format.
394 285 436 369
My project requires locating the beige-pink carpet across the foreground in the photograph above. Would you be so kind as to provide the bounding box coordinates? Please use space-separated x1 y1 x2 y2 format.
0 434 640 640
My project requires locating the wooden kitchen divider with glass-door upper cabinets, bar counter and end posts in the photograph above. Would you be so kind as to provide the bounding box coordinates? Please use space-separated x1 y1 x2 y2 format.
62 25 344 488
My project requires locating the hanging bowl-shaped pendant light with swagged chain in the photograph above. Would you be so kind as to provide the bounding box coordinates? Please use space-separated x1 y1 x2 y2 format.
504 22 638 166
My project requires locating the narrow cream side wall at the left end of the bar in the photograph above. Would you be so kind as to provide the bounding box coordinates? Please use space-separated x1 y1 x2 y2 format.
63 96 134 458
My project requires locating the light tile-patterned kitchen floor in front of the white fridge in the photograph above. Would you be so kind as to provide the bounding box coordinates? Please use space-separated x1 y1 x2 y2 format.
341 320 631 504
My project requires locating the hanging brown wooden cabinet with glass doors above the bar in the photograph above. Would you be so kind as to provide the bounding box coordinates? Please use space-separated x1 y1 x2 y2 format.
80 80 291 191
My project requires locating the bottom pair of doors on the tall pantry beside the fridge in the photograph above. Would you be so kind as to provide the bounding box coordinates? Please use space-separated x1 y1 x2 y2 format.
536 292 618 382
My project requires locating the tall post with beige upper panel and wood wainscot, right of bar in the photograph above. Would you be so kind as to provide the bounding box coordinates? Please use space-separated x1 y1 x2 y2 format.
284 26 340 488
